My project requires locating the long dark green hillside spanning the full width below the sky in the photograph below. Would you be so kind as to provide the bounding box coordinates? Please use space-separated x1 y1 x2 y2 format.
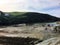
0 11 60 25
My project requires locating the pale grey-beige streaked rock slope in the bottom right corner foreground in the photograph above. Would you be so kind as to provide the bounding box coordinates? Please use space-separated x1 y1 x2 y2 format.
36 37 60 45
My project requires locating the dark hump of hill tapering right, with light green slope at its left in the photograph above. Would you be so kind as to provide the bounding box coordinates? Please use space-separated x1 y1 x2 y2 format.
10 12 60 23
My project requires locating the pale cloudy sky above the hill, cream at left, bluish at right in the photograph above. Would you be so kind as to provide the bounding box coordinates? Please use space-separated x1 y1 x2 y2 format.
0 0 60 18
